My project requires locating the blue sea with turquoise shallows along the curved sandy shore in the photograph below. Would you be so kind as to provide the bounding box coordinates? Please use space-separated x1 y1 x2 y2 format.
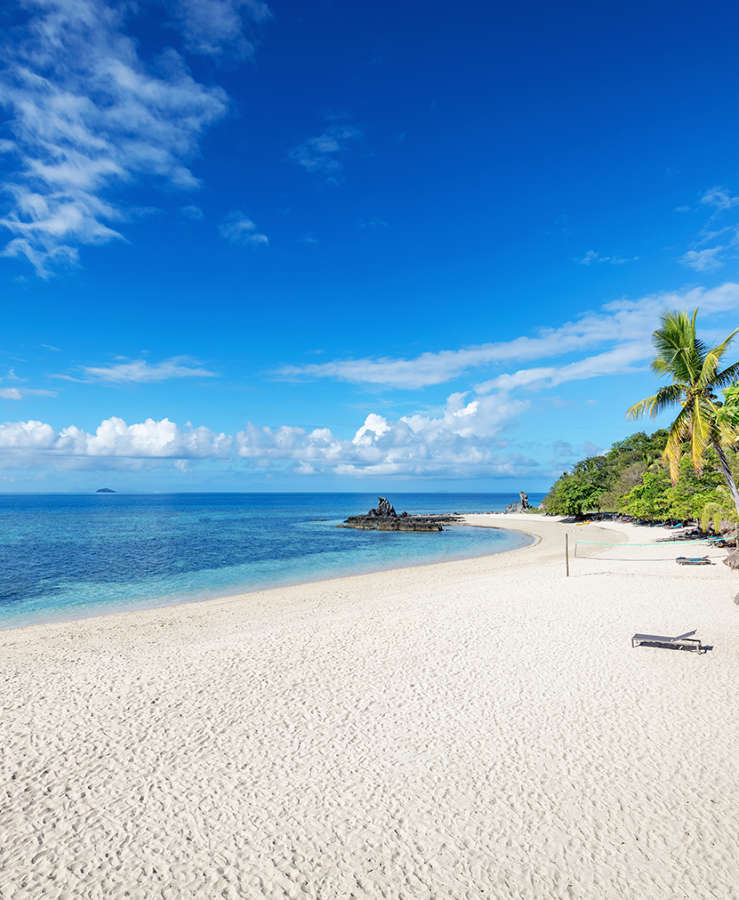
0 493 543 628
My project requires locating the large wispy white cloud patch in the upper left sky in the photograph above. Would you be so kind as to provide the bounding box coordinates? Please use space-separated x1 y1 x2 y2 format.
0 0 227 277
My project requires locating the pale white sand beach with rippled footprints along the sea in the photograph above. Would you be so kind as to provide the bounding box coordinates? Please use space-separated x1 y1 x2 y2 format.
0 515 739 900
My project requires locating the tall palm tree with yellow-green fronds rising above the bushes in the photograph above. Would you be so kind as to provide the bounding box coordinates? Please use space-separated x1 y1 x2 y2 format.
627 309 739 513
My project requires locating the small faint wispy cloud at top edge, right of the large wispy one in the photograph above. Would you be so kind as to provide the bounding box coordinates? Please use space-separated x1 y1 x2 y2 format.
175 0 272 57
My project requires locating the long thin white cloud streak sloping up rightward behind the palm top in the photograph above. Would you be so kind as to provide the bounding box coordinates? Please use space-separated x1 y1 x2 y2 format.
275 282 739 389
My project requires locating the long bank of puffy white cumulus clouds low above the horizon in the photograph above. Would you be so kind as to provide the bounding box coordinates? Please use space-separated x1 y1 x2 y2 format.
0 394 535 476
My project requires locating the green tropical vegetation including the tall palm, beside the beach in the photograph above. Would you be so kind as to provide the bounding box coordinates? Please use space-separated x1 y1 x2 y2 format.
542 310 739 531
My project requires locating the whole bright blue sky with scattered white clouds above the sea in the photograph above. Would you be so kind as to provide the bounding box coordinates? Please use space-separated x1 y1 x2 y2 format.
0 0 739 491
